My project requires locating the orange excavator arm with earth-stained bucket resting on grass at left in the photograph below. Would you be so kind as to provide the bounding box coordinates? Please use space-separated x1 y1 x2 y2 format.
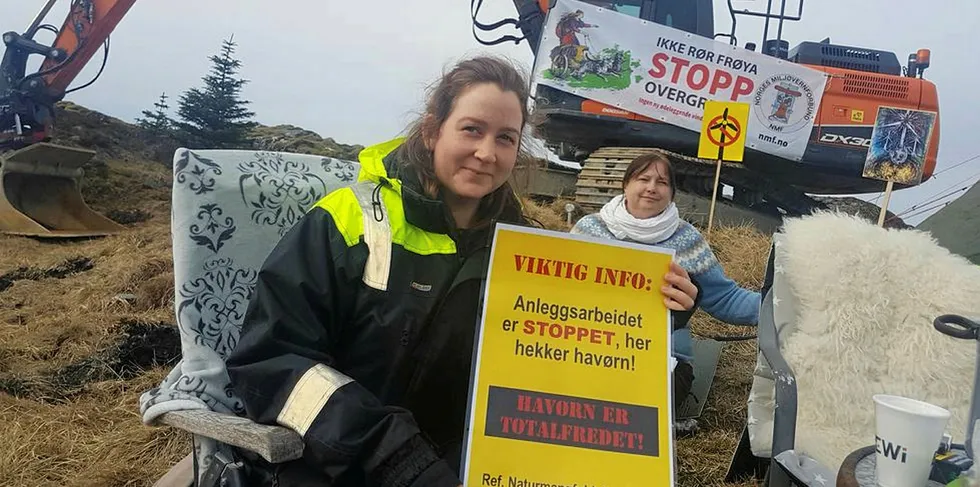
0 0 136 238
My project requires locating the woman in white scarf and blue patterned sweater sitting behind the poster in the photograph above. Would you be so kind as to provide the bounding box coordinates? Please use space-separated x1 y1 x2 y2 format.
571 153 761 436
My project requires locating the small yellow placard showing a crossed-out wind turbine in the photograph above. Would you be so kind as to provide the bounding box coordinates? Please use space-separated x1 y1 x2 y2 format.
698 100 749 162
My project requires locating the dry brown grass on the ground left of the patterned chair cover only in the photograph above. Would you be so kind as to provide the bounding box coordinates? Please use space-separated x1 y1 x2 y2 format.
0 158 190 487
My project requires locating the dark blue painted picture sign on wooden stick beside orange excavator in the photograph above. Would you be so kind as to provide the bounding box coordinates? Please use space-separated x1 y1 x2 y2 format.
861 107 936 227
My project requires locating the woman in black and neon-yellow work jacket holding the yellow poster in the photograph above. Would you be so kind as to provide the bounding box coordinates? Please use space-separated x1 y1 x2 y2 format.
227 57 697 487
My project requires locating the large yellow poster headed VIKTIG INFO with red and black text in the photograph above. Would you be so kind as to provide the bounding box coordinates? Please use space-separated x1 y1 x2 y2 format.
461 224 675 487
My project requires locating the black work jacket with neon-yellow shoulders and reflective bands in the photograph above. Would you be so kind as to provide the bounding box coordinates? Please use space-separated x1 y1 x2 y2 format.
226 141 525 487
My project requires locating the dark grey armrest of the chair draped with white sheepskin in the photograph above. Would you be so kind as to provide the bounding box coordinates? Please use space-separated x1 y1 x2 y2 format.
758 289 797 457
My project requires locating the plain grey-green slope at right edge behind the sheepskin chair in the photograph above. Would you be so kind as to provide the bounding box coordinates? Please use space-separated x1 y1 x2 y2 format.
916 183 980 265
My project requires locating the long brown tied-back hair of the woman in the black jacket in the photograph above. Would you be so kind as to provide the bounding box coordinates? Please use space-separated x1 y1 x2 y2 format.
399 56 530 225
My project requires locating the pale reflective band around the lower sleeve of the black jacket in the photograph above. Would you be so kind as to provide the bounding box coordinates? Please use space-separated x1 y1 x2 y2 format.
276 364 353 436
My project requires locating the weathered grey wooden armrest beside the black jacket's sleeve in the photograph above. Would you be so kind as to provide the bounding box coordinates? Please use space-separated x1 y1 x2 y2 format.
160 409 304 463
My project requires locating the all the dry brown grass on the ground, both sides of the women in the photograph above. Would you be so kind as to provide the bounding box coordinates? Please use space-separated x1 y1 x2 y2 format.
0 159 768 487
